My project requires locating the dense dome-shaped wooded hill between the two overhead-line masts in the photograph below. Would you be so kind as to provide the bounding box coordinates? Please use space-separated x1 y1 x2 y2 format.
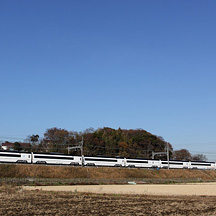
80 127 172 158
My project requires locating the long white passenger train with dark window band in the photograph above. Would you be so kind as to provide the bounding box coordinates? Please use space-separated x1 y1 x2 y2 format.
0 150 216 170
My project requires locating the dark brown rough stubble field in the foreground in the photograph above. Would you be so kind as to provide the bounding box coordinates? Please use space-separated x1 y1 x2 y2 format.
0 186 216 216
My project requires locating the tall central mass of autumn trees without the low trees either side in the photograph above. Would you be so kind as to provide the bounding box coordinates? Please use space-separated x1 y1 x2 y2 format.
38 127 172 158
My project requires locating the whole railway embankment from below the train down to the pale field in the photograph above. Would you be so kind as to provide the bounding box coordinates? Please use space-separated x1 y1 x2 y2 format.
0 164 216 184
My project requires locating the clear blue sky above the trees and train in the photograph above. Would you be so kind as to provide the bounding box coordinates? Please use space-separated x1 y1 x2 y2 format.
0 0 216 160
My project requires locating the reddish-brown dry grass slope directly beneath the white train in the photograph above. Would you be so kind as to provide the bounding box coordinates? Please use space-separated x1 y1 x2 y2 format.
0 165 216 180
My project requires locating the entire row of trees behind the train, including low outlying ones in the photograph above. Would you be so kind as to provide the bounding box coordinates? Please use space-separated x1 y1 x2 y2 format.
2 127 207 161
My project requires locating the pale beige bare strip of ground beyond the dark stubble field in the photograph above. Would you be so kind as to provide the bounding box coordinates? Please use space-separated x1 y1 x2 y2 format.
23 183 216 196
